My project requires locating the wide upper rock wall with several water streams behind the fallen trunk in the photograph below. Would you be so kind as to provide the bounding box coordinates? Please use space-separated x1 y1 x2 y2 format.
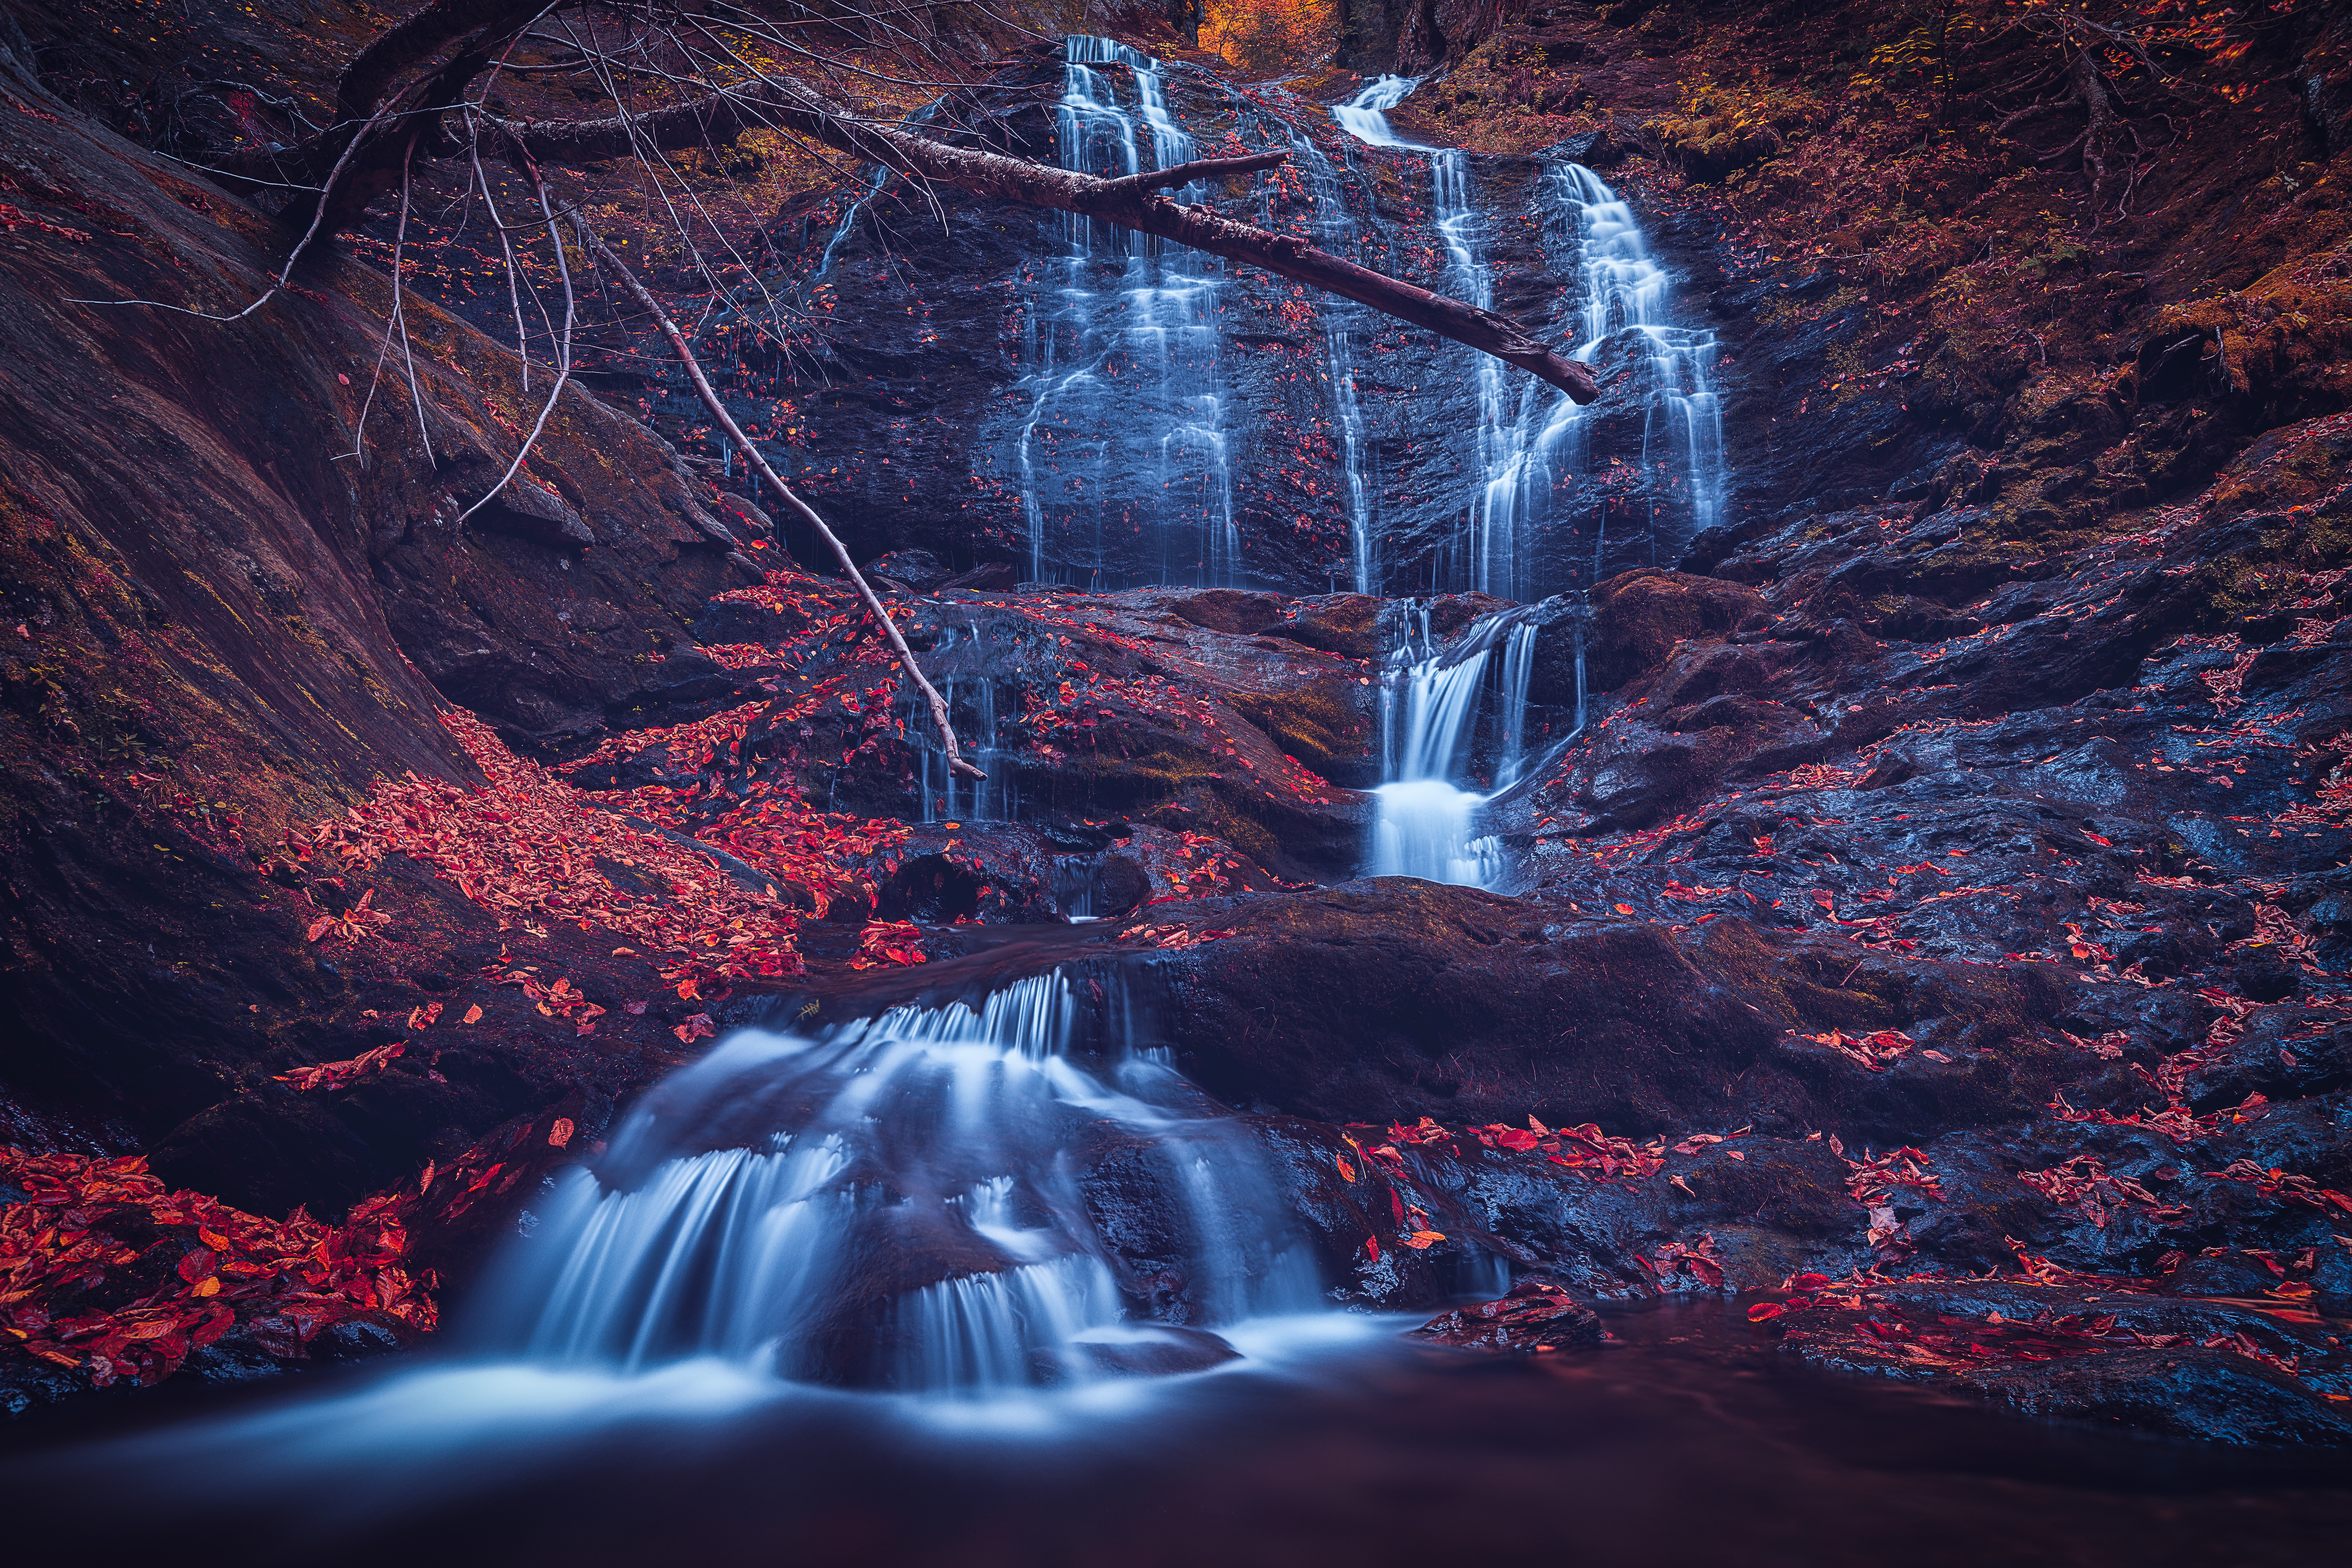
691 35 1729 602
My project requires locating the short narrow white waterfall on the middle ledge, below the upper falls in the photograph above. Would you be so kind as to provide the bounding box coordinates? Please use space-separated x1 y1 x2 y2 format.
1371 604 1505 886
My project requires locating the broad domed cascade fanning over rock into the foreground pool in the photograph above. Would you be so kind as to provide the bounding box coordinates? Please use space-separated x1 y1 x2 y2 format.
466 971 1322 1394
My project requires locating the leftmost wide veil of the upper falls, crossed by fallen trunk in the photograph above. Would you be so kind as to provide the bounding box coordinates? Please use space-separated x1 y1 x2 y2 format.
1011 35 1240 585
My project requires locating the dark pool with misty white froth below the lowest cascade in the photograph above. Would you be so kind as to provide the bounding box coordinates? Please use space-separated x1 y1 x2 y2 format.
0 1302 2352 1568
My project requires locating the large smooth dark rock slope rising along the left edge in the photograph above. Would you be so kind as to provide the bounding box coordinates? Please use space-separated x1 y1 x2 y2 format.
0 49 738 1213
